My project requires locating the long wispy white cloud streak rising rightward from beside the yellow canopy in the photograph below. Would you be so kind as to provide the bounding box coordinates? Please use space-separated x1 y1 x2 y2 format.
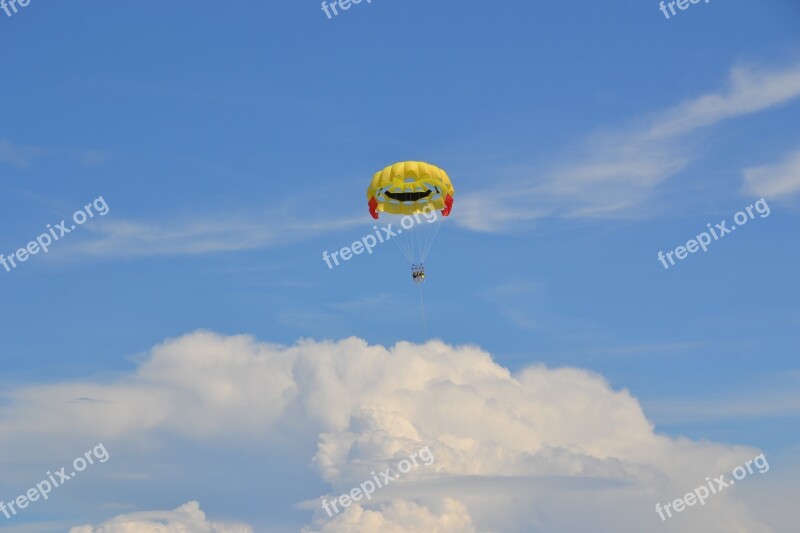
455 64 800 232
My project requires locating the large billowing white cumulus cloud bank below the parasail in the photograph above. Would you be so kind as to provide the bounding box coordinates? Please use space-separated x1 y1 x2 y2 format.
0 331 788 533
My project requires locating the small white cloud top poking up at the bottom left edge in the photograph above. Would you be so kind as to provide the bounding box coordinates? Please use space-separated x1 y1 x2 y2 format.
69 502 253 533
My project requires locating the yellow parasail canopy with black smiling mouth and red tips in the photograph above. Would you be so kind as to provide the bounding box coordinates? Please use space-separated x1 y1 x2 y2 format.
367 161 455 218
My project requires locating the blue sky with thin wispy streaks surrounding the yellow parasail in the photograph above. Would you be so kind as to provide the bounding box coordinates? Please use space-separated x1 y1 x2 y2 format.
0 0 800 531
